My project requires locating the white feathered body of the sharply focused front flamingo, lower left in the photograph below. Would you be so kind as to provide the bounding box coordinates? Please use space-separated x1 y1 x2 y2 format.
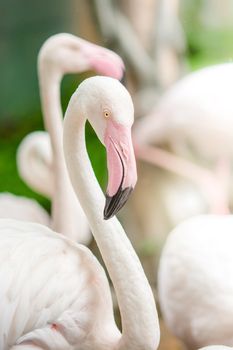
0 220 119 350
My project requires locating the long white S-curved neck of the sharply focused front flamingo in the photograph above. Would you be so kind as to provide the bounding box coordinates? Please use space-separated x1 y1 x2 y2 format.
64 100 159 350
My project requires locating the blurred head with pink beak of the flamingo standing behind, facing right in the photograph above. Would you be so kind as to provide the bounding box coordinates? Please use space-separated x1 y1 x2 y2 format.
38 33 125 80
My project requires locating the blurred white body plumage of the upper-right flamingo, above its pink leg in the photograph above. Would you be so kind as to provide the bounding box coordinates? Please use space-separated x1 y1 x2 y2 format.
135 63 233 161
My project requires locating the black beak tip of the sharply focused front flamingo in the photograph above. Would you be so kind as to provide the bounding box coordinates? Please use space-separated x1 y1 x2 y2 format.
104 187 133 220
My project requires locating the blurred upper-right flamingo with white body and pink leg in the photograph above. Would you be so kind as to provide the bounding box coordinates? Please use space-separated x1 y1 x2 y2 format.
134 63 233 214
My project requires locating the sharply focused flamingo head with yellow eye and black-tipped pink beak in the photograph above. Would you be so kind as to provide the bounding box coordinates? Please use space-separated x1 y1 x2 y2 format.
75 76 137 219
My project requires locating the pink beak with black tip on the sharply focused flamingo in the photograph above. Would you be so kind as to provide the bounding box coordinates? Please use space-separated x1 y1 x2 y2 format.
104 120 137 220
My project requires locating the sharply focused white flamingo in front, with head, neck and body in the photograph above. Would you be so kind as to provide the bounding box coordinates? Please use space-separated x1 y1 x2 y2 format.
0 76 159 350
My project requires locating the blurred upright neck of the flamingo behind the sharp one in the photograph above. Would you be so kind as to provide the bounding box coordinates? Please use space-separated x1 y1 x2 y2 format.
38 64 85 240
